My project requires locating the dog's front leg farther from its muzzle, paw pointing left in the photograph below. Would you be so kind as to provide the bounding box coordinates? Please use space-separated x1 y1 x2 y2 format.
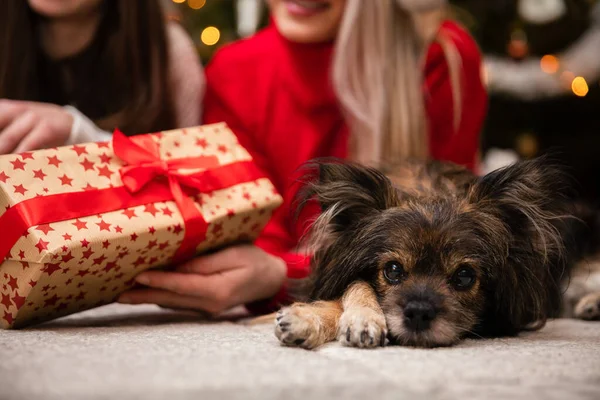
275 300 342 349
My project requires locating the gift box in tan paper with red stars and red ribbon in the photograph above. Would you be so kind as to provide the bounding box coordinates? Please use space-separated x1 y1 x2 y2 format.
0 124 282 329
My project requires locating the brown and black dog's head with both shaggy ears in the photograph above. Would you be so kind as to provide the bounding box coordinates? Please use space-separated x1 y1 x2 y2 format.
300 159 564 347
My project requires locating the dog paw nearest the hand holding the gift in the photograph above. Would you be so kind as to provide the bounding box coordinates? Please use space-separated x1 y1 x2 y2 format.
275 306 322 349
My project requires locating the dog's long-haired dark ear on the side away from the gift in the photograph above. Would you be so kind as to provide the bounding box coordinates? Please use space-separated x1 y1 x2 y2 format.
468 158 571 334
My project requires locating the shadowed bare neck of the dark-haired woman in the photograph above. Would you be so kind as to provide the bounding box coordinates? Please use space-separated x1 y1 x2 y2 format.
40 11 102 60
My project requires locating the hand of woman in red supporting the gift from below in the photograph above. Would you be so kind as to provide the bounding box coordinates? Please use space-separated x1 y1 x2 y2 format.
118 245 286 314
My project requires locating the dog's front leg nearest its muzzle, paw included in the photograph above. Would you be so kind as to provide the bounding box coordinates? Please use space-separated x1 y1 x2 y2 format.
338 281 387 348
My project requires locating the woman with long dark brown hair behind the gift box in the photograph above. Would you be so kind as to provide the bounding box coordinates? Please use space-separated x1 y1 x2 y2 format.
0 0 204 154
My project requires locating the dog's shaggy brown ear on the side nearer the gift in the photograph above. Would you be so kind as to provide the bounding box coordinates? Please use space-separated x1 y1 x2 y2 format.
297 159 398 299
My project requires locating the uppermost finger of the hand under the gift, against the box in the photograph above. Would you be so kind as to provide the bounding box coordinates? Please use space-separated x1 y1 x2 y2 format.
177 246 247 275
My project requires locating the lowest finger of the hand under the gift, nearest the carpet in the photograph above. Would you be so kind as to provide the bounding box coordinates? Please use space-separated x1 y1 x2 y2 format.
118 289 220 313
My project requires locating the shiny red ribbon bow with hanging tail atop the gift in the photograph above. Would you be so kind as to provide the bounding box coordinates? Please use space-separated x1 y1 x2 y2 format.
112 130 219 263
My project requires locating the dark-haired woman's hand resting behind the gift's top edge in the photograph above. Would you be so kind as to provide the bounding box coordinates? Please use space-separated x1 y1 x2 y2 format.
0 99 73 154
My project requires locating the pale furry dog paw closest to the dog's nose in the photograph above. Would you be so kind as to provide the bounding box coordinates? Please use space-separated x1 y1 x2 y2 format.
338 307 387 348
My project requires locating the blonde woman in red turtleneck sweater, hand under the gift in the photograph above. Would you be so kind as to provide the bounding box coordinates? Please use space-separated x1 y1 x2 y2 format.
120 0 487 313
